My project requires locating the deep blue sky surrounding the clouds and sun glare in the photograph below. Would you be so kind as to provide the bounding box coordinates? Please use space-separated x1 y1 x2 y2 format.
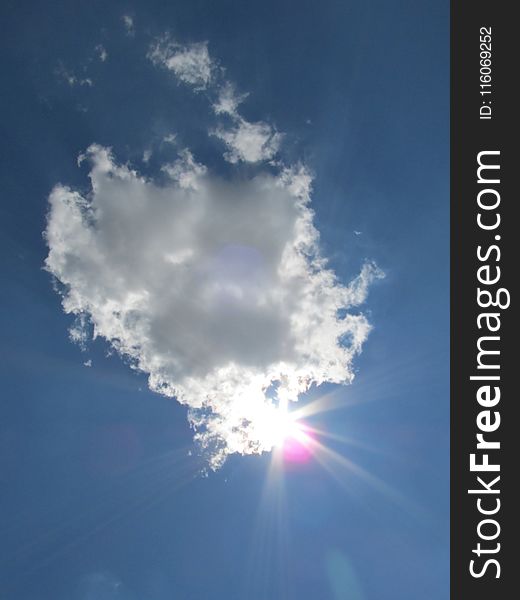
0 1 449 600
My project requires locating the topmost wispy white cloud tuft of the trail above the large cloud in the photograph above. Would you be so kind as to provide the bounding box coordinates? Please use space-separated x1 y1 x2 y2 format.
148 36 214 90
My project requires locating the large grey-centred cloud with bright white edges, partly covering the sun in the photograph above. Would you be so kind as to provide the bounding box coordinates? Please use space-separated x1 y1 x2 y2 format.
45 145 381 468
